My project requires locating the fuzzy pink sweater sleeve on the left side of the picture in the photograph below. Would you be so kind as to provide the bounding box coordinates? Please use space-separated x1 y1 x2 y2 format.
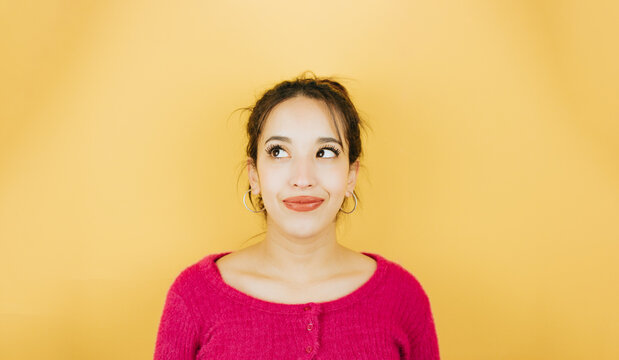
154 289 199 360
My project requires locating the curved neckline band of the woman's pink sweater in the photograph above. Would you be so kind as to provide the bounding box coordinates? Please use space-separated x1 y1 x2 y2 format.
200 251 387 314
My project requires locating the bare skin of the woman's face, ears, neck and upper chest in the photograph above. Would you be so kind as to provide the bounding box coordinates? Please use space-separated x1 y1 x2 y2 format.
217 96 376 303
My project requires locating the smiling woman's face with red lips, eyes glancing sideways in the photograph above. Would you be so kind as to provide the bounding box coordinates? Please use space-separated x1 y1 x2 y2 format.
248 96 359 238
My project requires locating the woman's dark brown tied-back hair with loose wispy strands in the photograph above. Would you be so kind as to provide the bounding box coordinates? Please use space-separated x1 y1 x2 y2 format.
245 72 367 221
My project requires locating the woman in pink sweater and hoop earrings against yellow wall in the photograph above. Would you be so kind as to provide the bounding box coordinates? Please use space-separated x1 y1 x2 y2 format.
155 75 439 360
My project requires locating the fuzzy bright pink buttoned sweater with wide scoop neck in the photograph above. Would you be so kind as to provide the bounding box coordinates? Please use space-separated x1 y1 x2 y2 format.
154 252 439 360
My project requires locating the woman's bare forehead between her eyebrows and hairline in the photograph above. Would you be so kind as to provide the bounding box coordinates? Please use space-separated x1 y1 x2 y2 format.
261 96 341 141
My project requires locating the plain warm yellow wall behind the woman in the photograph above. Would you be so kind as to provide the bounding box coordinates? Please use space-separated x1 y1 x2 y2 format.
0 0 619 360
